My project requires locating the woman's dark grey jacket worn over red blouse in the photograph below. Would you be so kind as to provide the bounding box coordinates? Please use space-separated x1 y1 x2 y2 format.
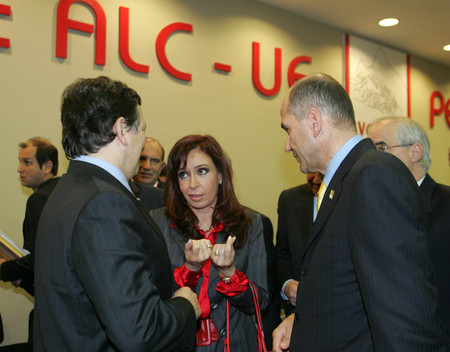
150 208 268 352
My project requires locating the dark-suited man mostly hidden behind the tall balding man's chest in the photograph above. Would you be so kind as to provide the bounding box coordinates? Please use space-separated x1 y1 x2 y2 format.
275 172 323 315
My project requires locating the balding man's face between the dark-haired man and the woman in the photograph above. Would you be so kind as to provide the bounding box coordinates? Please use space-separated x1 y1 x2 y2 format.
133 138 166 188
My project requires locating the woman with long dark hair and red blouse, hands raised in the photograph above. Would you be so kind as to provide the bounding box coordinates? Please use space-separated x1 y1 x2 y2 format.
150 135 268 352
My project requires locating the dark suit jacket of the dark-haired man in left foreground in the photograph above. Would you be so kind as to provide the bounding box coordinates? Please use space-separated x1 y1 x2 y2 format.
34 161 196 352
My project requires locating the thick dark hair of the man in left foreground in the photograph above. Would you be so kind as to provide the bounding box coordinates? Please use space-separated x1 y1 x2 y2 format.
61 76 141 159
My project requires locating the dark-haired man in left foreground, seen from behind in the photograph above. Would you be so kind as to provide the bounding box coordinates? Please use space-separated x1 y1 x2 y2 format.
34 77 200 352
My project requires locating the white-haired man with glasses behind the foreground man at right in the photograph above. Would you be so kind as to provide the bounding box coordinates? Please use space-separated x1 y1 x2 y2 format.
367 117 450 348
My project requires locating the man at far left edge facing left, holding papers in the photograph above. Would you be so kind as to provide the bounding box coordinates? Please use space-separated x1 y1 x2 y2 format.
0 137 59 352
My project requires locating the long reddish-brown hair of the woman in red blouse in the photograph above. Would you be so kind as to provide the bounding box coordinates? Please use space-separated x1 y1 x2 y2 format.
164 135 252 247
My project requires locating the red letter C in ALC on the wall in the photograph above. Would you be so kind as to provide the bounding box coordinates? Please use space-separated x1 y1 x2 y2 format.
156 22 192 81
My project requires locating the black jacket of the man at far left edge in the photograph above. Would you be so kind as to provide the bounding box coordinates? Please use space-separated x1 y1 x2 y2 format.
0 177 59 296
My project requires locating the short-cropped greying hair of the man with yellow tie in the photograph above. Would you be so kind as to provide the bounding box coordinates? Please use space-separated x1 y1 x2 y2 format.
289 73 356 131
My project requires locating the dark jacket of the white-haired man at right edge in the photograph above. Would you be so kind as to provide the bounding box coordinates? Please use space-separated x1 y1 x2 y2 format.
420 174 450 348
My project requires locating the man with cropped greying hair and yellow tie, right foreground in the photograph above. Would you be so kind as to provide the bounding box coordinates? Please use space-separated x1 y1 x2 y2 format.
273 74 445 352
